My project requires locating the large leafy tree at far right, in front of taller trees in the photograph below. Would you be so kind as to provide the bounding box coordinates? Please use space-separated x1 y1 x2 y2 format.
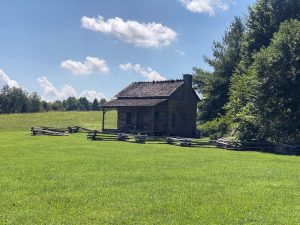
227 20 300 144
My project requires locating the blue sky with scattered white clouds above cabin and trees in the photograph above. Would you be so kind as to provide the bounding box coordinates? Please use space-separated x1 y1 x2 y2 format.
0 0 254 101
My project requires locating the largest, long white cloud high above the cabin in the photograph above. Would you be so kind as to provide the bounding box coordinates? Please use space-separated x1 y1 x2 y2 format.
81 16 177 48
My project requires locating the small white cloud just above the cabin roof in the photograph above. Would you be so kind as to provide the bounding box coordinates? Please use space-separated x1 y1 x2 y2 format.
119 63 166 81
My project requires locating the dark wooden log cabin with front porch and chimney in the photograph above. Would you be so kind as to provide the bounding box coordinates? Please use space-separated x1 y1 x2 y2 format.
102 74 199 137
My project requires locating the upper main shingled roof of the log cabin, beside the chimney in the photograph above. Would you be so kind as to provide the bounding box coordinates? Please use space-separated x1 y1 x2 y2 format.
116 80 184 98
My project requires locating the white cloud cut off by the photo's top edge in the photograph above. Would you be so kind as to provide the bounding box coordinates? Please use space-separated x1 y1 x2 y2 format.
180 0 229 16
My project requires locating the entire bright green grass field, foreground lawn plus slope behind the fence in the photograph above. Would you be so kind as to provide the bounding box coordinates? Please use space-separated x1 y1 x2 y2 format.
0 112 300 225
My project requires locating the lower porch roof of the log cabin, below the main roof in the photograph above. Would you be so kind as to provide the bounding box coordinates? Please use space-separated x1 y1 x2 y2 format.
104 99 167 108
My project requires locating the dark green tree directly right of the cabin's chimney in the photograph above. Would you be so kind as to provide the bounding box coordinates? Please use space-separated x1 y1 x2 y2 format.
194 17 244 122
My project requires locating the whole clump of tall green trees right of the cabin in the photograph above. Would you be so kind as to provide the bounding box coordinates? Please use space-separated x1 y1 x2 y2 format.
194 0 300 144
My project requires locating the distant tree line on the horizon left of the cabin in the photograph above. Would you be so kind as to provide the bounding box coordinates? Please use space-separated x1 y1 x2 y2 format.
0 85 106 113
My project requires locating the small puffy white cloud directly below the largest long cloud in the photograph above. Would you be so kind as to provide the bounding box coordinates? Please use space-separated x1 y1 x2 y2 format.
61 56 109 75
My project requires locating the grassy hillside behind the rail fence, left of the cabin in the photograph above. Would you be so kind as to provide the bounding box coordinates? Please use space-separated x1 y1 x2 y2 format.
0 111 117 131
